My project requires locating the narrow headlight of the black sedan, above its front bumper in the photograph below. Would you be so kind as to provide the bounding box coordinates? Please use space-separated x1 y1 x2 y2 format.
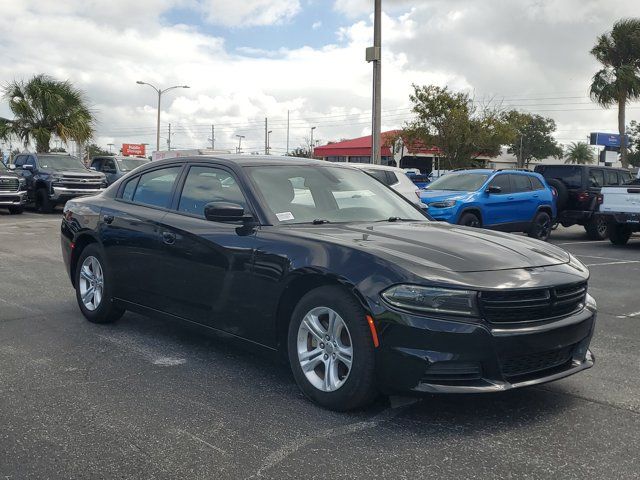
382 285 479 317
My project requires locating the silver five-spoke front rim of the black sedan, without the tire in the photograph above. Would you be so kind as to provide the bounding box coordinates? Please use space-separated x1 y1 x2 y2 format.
297 307 353 392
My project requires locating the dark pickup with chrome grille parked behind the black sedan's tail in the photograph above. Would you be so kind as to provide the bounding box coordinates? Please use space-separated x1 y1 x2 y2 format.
12 153 107 213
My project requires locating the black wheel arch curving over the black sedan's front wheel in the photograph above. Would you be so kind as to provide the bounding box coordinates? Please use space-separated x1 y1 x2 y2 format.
276 269 370 355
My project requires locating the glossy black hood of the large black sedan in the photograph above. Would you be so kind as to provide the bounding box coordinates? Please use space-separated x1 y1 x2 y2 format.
290 222 570 273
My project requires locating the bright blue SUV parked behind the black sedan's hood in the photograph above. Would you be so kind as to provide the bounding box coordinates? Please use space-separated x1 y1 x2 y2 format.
420 169 556 240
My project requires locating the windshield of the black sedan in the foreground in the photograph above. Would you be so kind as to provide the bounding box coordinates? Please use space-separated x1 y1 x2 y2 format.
246 165 427 224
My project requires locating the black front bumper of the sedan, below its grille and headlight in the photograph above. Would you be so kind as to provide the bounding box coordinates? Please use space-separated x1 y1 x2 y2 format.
376 308 596 393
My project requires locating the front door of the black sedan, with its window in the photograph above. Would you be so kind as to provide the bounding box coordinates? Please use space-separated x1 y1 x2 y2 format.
155 164 267 343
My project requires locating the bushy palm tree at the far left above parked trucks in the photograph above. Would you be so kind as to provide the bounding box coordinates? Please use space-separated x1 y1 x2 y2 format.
0 75 95 152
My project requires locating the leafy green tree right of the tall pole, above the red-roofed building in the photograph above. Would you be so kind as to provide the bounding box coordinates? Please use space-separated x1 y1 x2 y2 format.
401 85 513 168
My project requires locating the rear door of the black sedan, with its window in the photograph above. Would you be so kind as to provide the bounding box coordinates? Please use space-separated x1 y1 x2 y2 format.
100 164 183 309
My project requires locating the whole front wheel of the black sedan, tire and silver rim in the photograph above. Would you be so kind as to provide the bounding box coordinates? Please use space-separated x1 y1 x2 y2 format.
287 286 378 411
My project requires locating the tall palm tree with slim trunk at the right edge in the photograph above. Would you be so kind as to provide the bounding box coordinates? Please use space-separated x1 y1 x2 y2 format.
589 18 640 167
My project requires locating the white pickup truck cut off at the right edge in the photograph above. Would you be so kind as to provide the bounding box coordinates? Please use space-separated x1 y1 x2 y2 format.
600 180 640 245
